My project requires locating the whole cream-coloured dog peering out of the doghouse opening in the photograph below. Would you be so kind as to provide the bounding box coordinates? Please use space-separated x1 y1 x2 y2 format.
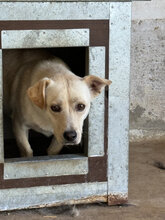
3 50 111 157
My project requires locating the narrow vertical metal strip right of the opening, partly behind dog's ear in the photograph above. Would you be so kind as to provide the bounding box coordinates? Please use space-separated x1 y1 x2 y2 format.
88 47 105 157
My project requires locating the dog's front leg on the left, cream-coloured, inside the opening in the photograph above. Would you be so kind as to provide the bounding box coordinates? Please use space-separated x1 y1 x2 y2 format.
13 120 33 157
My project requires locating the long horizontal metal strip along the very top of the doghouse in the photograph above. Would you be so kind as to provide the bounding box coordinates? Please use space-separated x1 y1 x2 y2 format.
0 1 109 21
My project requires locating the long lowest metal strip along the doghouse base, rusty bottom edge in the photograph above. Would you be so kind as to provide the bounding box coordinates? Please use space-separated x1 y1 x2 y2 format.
0 182 107 211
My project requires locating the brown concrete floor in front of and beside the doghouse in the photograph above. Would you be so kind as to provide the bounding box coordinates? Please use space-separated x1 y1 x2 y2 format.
0 141 165 220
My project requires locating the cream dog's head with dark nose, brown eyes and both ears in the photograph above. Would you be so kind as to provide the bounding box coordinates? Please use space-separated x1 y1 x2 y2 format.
27 74 111 145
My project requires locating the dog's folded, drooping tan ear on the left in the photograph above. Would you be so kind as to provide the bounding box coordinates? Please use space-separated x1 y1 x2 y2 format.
27 77 50 109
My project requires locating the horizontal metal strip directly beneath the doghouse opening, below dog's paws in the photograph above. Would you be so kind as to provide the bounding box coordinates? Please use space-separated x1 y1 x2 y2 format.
4 155 88 179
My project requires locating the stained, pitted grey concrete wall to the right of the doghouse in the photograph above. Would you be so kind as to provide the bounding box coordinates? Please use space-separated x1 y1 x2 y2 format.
130 0 165 141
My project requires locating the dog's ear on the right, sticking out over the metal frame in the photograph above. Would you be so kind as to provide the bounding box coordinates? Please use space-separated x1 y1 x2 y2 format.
84 75 112 98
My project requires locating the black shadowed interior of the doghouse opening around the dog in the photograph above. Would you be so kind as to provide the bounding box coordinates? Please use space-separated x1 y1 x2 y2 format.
2 47 88 159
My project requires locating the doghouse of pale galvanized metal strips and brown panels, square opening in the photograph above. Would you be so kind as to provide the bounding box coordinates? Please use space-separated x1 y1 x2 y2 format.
0 0 147 210
